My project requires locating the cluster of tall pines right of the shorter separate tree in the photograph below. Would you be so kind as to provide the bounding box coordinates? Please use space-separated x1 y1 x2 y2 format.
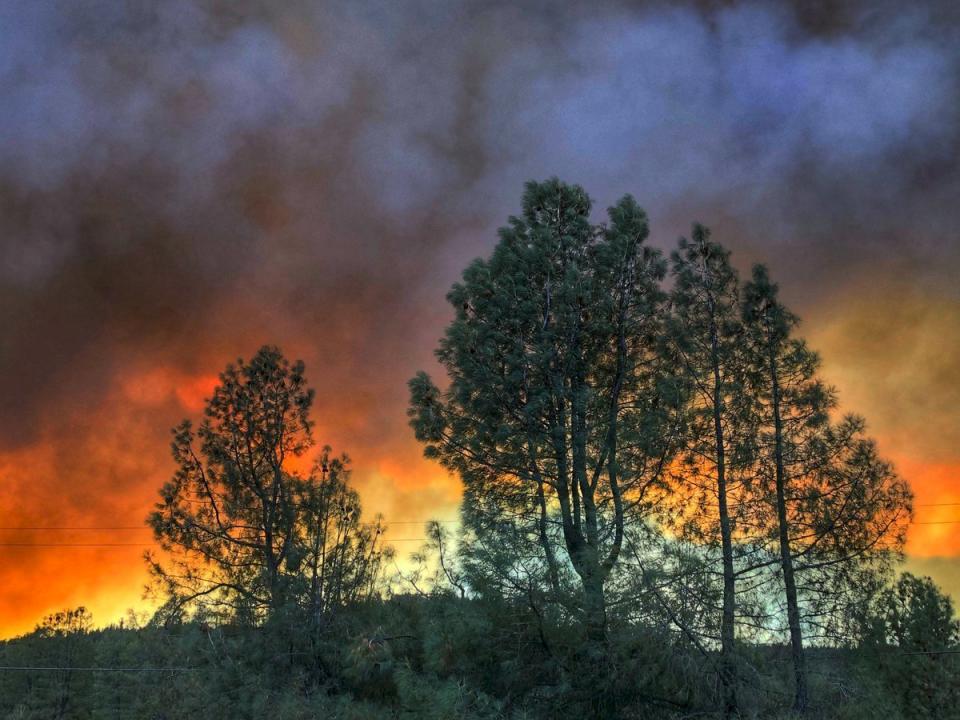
410 180 912 717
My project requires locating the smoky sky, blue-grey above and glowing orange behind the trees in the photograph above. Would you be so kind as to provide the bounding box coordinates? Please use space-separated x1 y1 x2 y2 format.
0 0 960 633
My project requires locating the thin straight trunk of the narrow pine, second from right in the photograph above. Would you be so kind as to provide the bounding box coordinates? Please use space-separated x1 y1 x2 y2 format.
710 308 739 718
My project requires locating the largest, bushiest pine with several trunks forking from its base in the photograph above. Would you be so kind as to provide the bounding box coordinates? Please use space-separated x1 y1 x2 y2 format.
409 180 676 642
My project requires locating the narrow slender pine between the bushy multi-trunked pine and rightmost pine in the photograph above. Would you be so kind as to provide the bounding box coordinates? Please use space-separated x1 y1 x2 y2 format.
667 224 752 717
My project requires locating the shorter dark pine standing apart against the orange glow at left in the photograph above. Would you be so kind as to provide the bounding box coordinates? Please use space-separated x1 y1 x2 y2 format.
147 347 382 620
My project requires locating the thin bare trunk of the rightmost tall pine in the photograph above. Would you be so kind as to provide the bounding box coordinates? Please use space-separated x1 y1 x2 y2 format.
770 349 807 713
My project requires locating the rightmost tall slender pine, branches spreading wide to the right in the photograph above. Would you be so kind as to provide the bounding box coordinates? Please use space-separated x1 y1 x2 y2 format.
742 265 910 713
